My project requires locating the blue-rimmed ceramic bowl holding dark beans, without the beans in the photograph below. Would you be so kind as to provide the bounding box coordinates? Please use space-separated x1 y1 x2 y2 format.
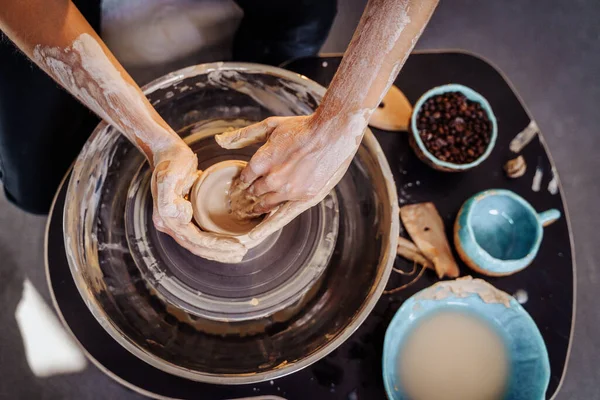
409 83 498 172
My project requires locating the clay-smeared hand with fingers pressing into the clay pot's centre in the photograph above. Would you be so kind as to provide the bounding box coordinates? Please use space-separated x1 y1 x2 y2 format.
215 114 367 220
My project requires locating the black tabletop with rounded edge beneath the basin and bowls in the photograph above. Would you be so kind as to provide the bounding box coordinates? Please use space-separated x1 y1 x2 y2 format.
48 53 573 399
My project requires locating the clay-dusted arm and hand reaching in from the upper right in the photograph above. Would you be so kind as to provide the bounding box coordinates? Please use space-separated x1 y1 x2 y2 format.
217 0 438 223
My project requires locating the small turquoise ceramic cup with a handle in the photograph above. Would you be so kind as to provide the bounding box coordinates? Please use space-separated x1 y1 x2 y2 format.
454 189 560 276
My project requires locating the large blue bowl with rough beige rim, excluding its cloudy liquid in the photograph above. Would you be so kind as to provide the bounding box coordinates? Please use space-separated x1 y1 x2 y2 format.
383 277 550 400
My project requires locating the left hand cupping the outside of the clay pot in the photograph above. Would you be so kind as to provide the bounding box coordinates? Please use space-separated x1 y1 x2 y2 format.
151 142 247 263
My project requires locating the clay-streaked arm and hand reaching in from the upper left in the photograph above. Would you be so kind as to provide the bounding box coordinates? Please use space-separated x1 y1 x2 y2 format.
0 0 246 261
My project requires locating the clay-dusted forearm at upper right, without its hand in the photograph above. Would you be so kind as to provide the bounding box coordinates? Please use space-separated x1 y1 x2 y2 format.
317 0 438 130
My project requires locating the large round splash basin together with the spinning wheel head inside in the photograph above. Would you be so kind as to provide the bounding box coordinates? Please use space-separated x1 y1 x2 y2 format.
63 63 399 384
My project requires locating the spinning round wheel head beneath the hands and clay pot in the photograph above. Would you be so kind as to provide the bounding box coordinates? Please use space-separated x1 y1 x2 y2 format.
125 120 339 321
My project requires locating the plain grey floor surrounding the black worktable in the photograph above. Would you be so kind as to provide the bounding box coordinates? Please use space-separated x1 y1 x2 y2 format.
0 0 600 400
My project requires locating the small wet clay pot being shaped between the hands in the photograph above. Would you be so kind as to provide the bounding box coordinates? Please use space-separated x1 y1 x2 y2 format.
190 160 261 241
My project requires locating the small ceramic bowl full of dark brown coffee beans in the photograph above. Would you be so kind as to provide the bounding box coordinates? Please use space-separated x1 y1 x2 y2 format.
410 84 498 172
